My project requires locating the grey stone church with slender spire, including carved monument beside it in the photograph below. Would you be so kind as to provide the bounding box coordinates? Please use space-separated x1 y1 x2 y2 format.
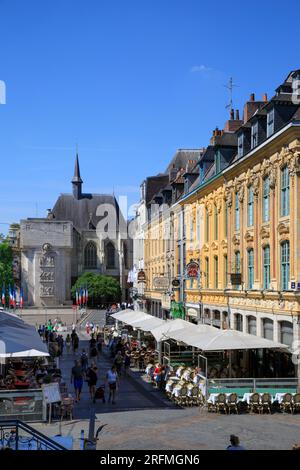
20 154 132 307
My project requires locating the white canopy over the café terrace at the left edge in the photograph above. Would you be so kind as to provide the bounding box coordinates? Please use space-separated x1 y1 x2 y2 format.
0 311 49 358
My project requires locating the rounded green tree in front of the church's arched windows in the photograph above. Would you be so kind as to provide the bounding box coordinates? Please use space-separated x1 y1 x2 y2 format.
72 273 121 307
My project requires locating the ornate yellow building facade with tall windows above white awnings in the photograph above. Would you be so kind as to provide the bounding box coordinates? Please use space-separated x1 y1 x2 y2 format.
179 124 300 345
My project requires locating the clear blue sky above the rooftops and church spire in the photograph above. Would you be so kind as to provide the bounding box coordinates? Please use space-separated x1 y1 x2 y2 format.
0 0 300 232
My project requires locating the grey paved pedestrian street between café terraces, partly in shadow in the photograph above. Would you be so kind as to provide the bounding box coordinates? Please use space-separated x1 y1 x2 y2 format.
35 333 300 450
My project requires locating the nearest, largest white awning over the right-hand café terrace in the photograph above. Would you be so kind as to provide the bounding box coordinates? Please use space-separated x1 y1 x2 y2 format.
170 325 288 351
